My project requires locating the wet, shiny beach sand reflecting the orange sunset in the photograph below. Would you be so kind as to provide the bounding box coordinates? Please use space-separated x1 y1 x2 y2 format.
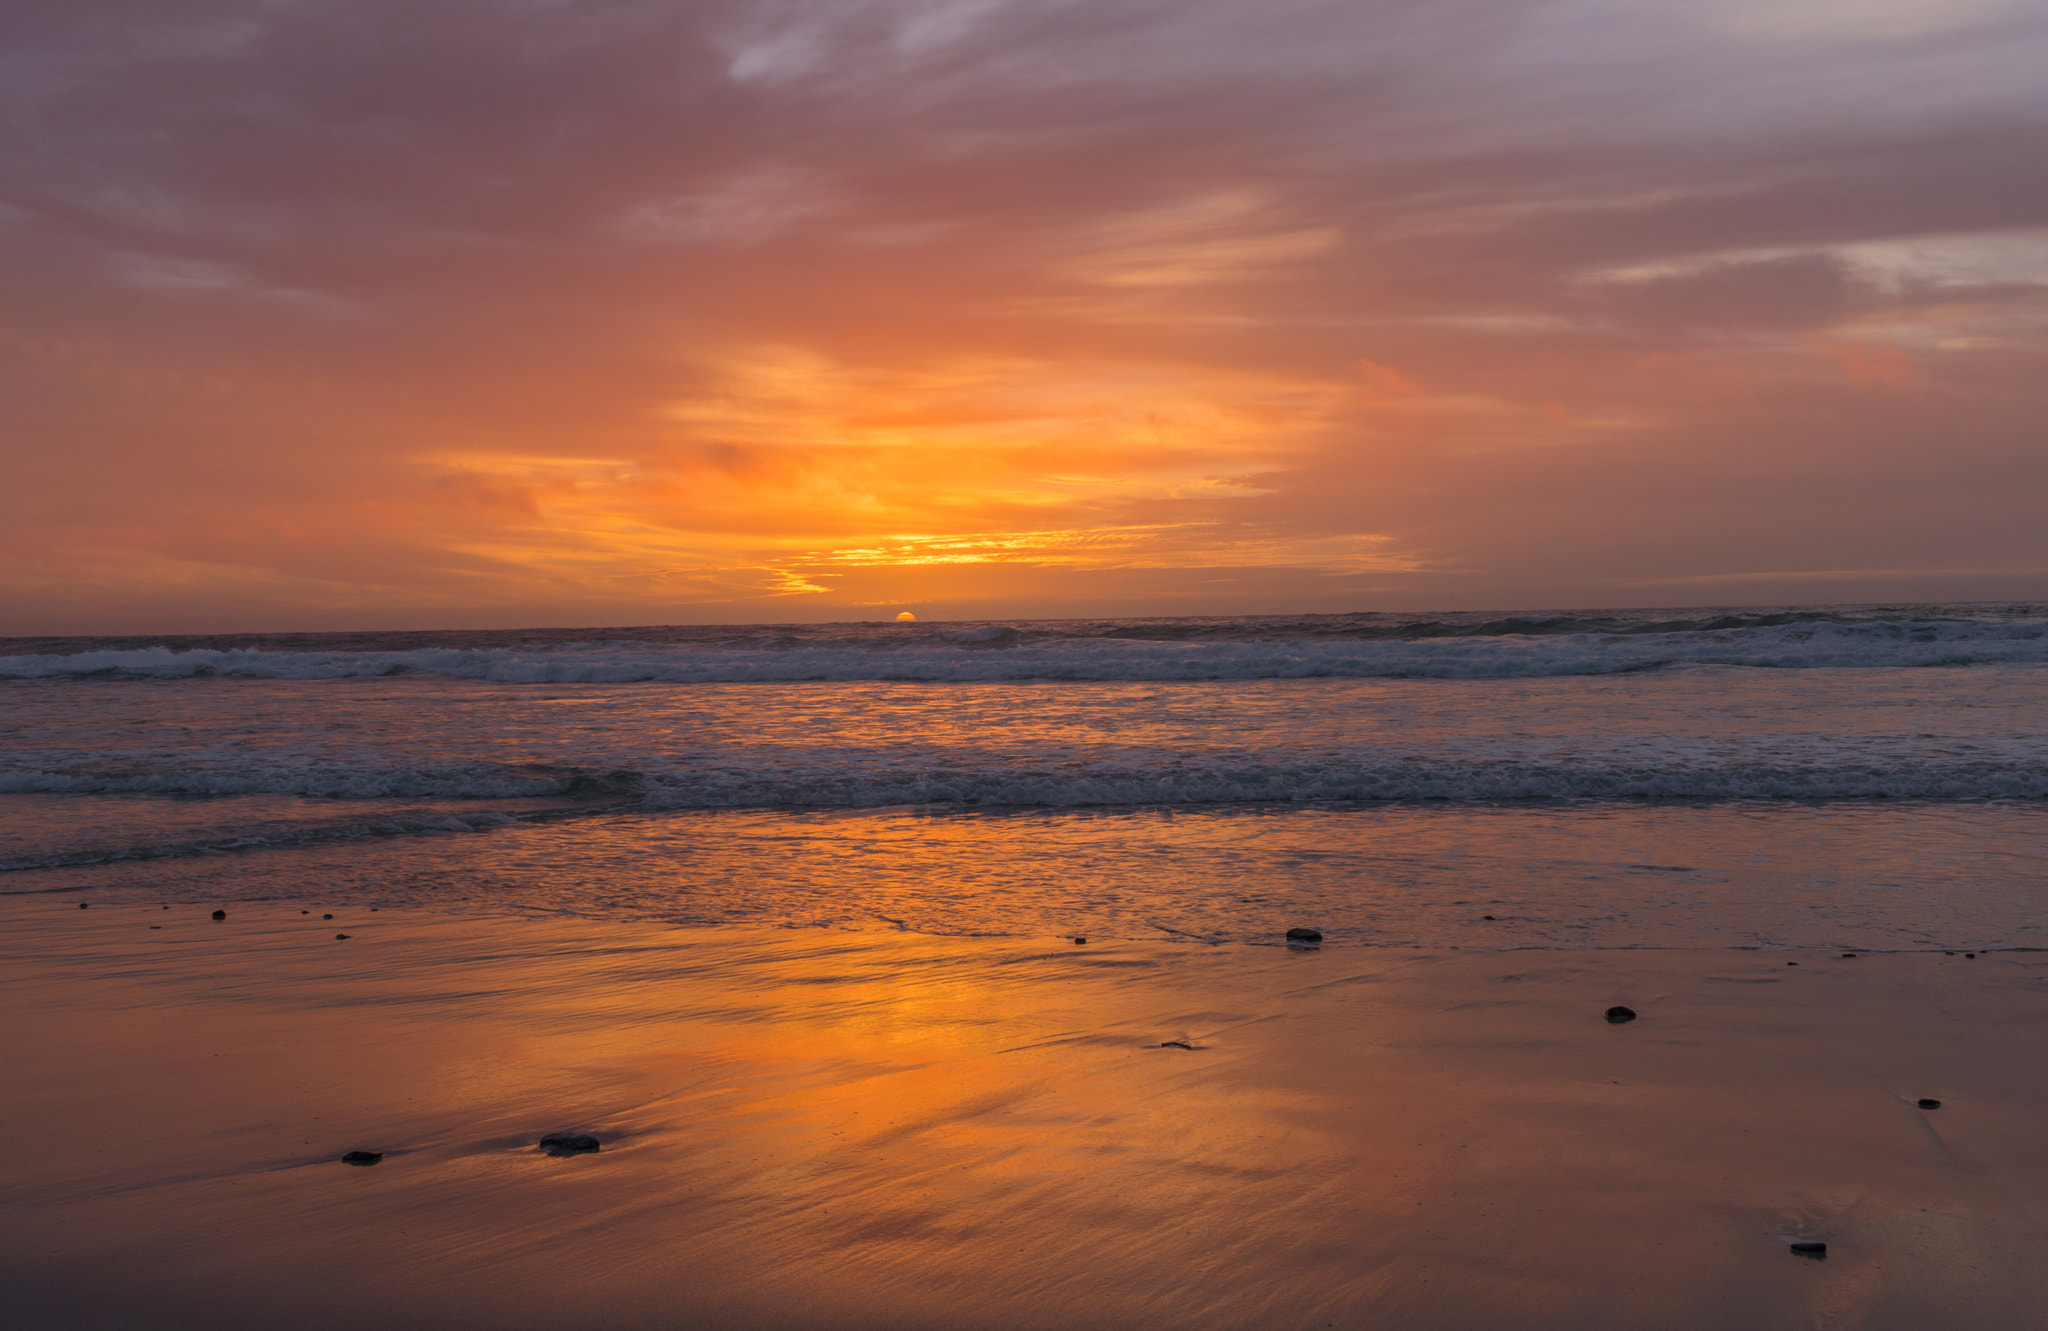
0 897 2048 1331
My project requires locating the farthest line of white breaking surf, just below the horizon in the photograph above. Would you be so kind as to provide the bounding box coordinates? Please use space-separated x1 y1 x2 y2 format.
0 618 2048 684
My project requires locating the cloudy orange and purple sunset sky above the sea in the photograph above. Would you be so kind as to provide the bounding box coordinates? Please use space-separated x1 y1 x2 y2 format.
0 0 2048 635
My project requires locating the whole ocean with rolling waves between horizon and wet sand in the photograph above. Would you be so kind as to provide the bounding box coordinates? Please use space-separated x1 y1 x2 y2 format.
0 602 2048 950
